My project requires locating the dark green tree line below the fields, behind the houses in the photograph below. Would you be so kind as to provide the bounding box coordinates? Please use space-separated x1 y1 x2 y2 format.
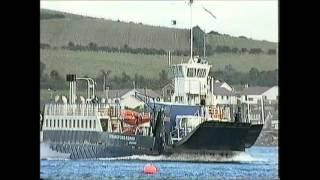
40 62 278 90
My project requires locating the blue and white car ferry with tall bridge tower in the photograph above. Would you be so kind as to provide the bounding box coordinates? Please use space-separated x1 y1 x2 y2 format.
40 3 264 159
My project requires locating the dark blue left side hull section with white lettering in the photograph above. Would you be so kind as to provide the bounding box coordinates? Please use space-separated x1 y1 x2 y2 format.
43 130 159 159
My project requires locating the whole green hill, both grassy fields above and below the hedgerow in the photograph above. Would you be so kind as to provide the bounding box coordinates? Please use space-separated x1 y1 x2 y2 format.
40 9 278 78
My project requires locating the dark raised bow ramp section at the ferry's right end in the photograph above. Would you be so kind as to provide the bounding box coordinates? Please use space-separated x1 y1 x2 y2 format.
166 121 263 154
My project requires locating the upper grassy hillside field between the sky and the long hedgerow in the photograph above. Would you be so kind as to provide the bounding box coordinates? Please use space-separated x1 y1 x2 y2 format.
40 9 277 51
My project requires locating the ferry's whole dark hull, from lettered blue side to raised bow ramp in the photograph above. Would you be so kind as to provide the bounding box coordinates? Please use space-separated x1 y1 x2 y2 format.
43 121 263 159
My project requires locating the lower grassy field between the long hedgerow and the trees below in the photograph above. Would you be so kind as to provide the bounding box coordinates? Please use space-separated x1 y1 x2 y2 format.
40 49 278 78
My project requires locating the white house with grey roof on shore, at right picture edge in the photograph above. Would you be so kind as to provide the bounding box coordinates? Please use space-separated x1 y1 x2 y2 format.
239 86 278 104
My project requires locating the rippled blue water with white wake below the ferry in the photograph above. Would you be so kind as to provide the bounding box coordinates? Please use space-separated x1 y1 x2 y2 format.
40 147 278 179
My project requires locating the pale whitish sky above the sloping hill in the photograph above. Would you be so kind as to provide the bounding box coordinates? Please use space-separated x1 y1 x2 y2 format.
40 0 279 42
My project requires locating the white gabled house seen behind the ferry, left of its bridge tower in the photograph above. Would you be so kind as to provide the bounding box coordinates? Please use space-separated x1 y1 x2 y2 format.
107 89 160 109
